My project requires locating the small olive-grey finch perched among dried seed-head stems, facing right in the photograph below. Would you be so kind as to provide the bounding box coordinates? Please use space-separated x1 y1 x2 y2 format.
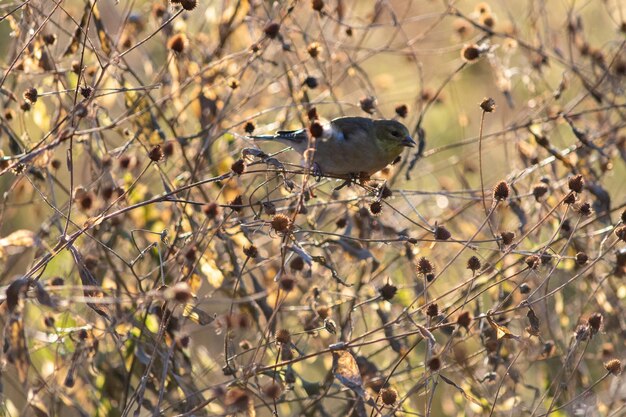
250 117 415 178
